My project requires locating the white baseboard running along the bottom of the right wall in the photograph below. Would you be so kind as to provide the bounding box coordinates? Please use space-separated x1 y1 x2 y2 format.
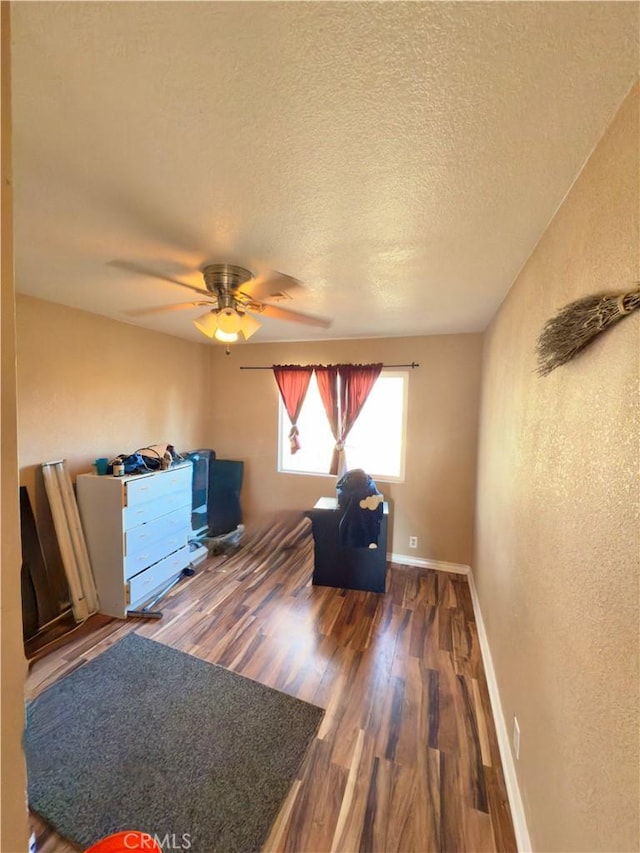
468 570 531 853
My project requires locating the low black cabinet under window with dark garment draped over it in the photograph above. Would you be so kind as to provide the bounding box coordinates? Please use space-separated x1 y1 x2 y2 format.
309 498 389 592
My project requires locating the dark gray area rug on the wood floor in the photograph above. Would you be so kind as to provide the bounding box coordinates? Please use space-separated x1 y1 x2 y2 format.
25 634 324 853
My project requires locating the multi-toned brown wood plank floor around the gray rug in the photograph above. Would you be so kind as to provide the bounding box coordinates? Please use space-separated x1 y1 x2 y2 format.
27 517 517 853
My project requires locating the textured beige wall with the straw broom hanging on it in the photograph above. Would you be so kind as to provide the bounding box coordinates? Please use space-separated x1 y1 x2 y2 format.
474 83 640 851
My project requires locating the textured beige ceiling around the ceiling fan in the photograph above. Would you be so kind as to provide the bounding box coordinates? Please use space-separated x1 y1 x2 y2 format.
11 2 639 342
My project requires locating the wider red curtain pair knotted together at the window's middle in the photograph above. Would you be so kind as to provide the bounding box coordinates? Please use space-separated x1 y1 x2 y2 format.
316 364 382 475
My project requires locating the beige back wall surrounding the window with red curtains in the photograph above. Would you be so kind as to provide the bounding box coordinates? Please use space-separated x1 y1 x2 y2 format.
209 335 482 564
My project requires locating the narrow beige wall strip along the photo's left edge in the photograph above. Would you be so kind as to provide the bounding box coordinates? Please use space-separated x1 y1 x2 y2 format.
0 3 28 853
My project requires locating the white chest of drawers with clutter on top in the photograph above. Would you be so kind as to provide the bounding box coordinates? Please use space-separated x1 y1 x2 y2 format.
76 462 193 618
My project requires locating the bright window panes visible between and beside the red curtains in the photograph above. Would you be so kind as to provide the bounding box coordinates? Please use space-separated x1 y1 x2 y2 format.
278 370 409 480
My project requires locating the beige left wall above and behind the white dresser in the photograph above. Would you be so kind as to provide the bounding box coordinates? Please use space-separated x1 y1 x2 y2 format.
16 295 210 564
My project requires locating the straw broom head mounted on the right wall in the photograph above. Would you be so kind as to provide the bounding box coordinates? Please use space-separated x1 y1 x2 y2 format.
536 288 640 376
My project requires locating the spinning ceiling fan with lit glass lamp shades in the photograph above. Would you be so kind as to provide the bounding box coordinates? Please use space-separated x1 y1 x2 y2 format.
109 261 331 344
